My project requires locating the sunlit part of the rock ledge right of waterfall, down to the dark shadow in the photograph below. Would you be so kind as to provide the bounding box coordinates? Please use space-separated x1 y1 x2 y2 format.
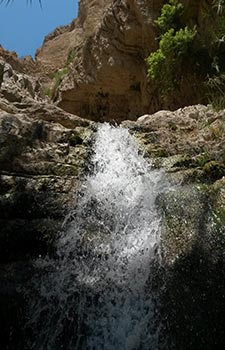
123 105 225 265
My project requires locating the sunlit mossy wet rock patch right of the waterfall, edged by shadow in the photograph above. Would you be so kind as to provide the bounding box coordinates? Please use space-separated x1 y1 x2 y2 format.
159 185 209 264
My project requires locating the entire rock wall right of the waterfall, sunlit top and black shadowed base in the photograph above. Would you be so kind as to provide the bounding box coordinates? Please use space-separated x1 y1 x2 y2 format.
123 105 225 350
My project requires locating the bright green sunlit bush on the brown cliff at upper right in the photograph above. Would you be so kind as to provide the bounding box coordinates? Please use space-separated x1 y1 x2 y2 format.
147 0 197 95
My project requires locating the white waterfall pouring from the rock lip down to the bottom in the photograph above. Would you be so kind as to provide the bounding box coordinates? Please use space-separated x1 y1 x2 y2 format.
27 124 165 350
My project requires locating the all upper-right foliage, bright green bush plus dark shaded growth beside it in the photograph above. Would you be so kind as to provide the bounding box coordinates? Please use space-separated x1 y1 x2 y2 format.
146 0 225 109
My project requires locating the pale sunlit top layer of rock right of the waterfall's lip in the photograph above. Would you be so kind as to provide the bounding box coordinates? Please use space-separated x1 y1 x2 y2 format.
123 105 225 164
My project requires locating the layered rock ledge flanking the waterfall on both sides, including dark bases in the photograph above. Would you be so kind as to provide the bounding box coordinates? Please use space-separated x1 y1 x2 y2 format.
0 59 225 350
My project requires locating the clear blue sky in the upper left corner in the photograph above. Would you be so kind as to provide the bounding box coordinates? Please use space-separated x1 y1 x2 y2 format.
0 0 78 57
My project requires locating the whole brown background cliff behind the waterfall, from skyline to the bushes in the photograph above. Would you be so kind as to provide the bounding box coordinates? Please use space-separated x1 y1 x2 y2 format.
0 0 214 122
